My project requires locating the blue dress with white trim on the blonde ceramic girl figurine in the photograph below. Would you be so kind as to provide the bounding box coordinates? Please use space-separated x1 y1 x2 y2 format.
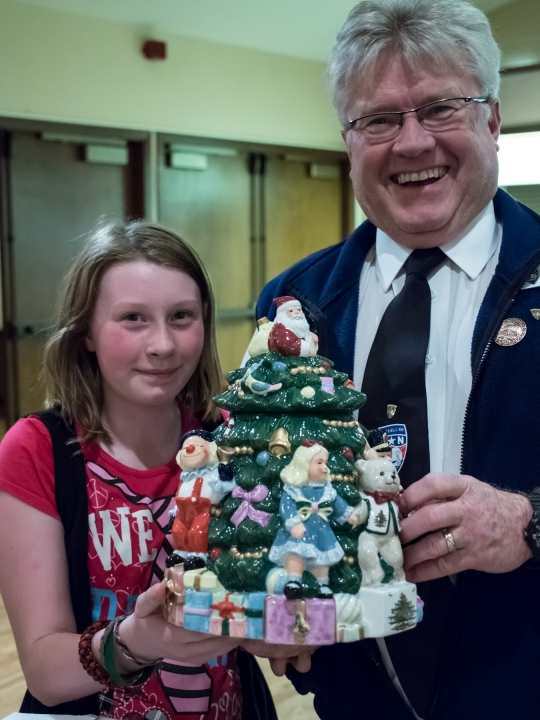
268 482 353 570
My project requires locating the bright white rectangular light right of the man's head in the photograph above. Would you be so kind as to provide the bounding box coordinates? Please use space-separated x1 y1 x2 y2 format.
499 132 540 187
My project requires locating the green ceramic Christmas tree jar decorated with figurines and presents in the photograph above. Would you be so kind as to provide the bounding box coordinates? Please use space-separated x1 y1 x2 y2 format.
165 297 417 644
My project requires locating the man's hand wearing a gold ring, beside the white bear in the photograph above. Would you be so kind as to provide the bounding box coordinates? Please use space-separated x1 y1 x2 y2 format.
400 473 532 582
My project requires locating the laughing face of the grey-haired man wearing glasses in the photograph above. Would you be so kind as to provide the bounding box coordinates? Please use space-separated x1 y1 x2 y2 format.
343 58 500 248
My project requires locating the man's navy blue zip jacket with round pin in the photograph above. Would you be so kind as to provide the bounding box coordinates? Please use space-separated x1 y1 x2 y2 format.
257 190 540 720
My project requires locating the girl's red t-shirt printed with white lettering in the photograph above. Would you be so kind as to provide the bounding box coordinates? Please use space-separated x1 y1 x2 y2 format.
0 412 241 720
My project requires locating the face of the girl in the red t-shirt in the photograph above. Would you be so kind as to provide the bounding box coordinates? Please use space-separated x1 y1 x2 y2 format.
86 260 204 406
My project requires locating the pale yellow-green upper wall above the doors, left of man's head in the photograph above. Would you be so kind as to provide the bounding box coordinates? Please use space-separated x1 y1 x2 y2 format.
0 0 343 150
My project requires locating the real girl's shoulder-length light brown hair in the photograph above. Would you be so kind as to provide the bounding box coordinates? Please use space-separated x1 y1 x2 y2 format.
43 221 222 442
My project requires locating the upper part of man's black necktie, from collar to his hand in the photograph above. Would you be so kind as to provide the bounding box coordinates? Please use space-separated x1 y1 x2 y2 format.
359 248 446 487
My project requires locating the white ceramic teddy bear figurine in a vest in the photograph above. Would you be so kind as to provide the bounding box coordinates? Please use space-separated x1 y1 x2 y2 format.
355 451 405 587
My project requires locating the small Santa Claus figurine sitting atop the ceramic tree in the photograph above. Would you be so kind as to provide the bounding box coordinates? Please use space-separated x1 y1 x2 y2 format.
268 295 319 357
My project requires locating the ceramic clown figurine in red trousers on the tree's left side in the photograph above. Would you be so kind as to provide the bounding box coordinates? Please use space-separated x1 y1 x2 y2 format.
169 430 236 569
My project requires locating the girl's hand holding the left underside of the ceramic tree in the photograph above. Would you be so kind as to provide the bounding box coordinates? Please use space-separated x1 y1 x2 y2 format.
119 583 242 665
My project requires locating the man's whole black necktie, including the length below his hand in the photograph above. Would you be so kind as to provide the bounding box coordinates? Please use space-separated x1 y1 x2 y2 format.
359 248 453 720
